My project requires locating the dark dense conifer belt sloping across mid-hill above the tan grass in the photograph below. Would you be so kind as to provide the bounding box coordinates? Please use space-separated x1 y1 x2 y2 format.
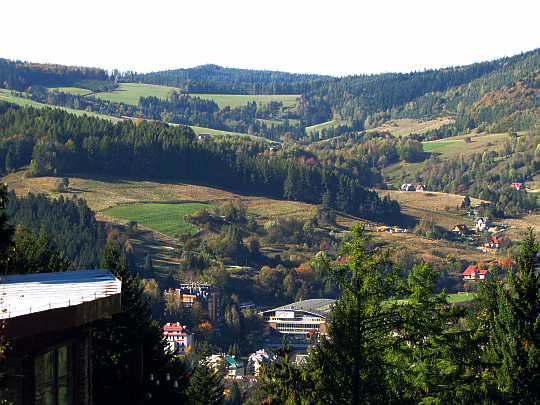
0 104 399 222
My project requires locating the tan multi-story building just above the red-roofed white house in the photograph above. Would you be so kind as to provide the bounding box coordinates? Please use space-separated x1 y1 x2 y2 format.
163 283 219 321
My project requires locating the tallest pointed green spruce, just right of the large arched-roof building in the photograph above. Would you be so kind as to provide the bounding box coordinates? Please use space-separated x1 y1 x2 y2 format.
311 224 405 404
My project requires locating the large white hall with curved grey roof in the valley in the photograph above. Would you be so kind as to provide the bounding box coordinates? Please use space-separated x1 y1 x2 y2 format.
259 299 336 339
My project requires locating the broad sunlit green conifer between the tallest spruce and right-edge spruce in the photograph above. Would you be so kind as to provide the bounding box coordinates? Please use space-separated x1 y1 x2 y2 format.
387 263 486 404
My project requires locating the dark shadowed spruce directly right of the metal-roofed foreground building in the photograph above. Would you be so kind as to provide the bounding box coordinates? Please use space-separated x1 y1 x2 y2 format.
92 243 185 405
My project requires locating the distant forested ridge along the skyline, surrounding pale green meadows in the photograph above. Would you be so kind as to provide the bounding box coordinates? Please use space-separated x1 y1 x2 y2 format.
0 46 540 141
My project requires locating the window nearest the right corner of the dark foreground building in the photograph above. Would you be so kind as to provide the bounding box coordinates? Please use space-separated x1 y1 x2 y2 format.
45 345 73 405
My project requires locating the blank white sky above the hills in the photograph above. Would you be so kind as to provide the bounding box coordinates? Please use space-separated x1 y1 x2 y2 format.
0 0 540 76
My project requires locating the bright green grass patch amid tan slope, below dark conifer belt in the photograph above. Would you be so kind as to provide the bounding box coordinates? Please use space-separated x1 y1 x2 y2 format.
102 203 212 237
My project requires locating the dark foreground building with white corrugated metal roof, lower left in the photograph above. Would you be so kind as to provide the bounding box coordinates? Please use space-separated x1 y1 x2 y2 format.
0 269 122 405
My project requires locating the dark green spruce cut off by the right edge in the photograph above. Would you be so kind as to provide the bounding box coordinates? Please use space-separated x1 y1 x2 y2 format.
478 228 540 404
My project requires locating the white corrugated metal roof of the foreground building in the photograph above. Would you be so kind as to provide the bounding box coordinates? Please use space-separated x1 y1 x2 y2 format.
0 269 122 319
